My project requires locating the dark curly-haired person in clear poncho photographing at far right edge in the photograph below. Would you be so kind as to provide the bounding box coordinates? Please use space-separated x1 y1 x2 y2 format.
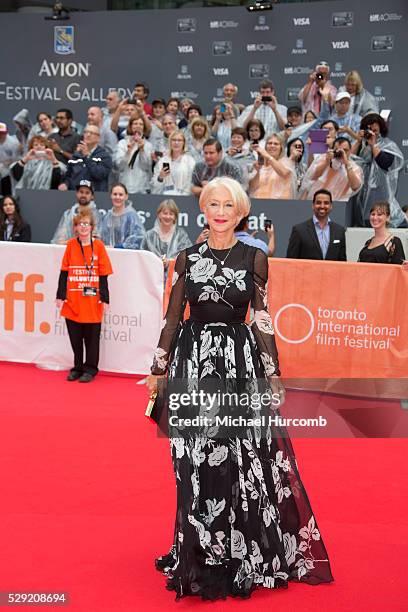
352 113 408 227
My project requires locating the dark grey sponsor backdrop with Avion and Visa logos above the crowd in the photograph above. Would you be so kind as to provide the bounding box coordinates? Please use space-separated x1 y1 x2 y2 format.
0 0 408 196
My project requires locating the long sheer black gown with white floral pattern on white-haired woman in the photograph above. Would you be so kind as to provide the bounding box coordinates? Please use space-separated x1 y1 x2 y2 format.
152 242 333 600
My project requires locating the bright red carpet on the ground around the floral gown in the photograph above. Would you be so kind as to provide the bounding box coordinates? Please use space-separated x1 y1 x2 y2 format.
0 364 408 612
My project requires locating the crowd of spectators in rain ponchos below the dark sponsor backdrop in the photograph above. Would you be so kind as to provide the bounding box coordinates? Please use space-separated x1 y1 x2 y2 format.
0 62 408 256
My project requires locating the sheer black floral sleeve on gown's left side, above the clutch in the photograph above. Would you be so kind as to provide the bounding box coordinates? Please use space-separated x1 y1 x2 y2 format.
151 250 186 375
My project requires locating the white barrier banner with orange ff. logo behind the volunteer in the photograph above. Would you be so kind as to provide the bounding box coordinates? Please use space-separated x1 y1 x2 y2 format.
0 242 163 374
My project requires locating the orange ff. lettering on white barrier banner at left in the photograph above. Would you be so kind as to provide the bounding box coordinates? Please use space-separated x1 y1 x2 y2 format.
0 272 51 334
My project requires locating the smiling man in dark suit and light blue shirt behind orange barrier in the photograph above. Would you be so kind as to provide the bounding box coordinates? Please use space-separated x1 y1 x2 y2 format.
286 189 347 261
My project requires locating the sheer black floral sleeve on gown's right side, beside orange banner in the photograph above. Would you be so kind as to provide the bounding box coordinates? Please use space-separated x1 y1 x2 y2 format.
250 249 280 377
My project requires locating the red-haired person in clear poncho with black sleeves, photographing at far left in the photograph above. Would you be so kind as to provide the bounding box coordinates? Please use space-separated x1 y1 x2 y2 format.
10 136 66 189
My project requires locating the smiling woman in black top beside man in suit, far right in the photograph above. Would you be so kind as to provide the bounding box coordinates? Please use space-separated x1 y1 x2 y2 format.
358 202 407 268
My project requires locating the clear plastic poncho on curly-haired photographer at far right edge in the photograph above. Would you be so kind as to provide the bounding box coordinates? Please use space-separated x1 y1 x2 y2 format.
354 136 406 227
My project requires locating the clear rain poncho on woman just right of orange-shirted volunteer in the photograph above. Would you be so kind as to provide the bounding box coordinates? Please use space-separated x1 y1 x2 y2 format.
100 202 146 249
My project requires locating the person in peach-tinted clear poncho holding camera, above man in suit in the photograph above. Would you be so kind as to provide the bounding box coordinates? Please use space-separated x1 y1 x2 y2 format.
300 136 363 201
